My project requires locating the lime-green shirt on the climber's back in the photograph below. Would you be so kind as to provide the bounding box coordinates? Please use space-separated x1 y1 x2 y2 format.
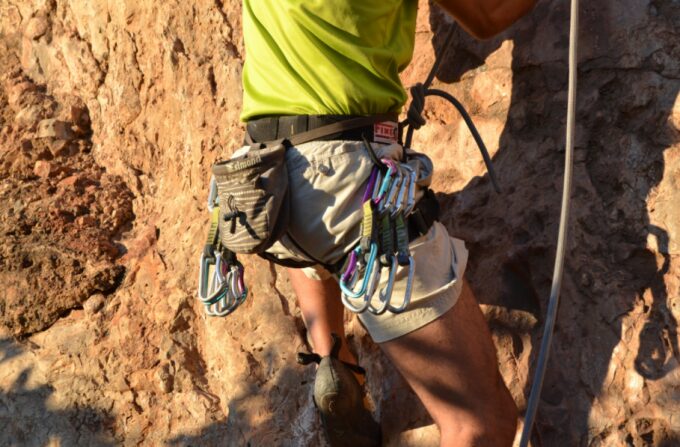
241 0 418 121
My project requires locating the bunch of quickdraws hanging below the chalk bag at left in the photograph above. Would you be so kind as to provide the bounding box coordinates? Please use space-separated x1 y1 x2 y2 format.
198 177 248 317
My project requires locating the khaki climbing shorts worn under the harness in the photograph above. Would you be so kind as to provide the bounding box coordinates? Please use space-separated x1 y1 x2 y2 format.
260 141 468 343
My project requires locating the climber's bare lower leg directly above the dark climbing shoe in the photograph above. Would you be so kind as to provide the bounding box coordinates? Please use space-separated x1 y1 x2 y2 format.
288 269 357 364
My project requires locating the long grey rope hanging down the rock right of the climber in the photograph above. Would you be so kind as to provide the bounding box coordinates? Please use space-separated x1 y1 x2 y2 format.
520 0 579 447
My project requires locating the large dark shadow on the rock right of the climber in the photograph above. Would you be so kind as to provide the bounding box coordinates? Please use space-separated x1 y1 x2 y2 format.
430 1 680 446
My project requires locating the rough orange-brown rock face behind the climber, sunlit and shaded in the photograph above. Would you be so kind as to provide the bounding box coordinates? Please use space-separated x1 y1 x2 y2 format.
0 0 680 446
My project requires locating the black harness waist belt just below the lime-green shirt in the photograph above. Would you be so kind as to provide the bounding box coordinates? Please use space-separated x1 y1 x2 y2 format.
246 113 398 144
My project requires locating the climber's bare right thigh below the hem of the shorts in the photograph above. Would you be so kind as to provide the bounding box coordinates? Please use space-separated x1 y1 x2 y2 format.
380 283 516 445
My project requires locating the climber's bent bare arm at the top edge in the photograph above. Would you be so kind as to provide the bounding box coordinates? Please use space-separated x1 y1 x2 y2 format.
436 0 536 39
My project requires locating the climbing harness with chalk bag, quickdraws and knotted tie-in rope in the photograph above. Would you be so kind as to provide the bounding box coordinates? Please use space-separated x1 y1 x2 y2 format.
198 22 500 316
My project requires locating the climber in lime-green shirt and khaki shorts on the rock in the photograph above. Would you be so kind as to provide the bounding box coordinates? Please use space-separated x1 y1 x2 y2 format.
241 0 535 447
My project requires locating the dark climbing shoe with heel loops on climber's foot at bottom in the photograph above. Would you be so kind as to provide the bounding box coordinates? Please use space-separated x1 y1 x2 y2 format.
298 334 382 447
